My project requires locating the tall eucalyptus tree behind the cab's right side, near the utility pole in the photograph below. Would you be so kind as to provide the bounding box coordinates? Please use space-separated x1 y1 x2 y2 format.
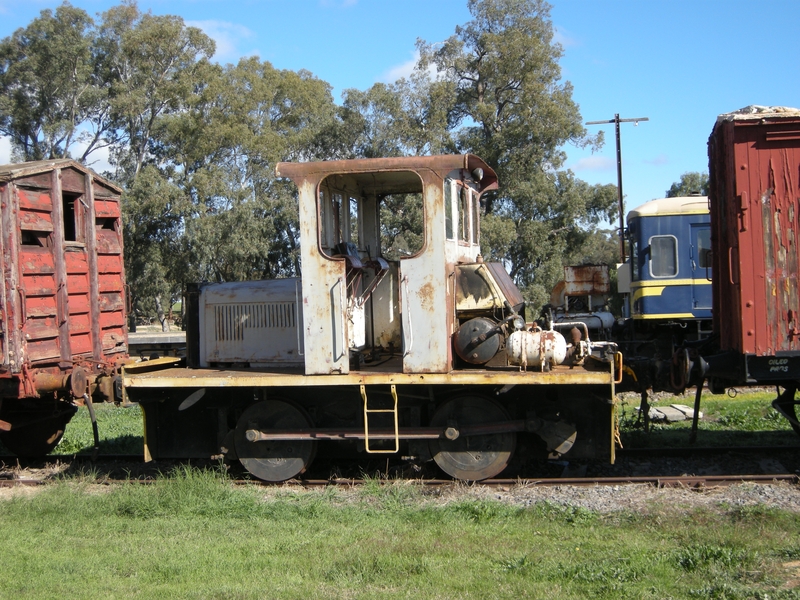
417 0 616 303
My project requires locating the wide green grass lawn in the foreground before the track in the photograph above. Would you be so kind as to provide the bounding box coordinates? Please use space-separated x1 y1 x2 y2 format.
0 468 800 599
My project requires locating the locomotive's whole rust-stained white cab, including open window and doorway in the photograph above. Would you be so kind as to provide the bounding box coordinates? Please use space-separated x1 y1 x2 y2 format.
277 156 521 374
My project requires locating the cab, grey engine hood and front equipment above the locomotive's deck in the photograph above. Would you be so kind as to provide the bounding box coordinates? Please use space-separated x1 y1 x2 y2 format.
199 156 536 375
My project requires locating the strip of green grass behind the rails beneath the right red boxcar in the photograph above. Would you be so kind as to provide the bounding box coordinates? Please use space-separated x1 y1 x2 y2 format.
620 390 800 446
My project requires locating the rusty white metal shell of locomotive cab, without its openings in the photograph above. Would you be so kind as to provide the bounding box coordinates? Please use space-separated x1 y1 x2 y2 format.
276 155 497 375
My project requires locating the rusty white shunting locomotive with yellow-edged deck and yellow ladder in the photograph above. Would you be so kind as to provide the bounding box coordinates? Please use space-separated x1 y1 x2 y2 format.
125 155 621 481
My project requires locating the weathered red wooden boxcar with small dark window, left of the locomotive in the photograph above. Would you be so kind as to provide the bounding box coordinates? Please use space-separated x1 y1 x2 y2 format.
0 160 127 455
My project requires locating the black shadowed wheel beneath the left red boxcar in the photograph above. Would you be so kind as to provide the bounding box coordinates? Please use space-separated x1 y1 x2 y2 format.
0 400 78 458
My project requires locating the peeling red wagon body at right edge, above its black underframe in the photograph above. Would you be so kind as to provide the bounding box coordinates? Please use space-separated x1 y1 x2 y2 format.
709 112 800 356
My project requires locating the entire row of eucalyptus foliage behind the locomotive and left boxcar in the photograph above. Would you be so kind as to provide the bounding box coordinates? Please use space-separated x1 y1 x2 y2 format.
0 0 616 312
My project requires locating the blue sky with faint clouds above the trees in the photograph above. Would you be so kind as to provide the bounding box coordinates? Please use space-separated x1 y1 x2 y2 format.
0 0 800 210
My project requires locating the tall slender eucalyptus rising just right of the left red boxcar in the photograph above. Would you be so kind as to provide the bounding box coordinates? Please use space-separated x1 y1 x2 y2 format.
89 0 214 329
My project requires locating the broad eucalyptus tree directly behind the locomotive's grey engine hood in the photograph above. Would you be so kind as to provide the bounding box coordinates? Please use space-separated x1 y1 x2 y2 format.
164 57 336 288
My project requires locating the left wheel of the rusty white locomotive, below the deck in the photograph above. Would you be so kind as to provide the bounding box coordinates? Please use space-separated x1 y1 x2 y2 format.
234 400 317 481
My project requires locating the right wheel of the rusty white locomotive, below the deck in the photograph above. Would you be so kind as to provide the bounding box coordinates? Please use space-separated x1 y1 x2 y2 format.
429 396 517 481
